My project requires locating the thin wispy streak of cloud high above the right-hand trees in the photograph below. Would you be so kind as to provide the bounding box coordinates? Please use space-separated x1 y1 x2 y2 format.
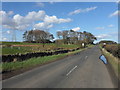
68 6 97 15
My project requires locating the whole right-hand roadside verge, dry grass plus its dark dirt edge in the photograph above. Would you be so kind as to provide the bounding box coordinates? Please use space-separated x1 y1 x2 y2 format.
101 48 120 87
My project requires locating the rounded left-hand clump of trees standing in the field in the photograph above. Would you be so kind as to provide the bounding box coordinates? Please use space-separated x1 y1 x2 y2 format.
23 30 54 47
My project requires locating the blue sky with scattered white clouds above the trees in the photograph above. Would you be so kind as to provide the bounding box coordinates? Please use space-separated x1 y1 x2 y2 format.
0 2 120 42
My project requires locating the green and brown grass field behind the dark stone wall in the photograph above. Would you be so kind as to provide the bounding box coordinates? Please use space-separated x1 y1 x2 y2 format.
2 42 80 55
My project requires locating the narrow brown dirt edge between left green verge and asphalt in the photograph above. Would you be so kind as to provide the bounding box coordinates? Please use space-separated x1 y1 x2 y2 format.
2 46 93 80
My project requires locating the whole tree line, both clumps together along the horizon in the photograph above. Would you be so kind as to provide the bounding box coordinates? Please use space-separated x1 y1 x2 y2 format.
23 30 97 44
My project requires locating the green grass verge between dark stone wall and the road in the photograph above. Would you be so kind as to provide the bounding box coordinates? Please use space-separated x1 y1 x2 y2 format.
2 48 86 71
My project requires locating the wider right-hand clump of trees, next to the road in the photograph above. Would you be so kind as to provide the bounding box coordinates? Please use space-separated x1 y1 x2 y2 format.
57 30 97 44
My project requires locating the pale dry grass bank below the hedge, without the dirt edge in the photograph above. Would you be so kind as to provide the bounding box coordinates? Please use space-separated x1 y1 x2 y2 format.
102 49 120 77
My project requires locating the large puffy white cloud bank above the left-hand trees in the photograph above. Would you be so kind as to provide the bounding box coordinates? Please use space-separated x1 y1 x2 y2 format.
0 10 71 30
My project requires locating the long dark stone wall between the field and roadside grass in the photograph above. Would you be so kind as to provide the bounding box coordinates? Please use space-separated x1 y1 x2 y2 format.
2 48 79 62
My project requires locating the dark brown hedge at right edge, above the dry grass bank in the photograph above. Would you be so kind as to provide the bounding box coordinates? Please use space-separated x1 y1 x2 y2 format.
104 44 120 58
